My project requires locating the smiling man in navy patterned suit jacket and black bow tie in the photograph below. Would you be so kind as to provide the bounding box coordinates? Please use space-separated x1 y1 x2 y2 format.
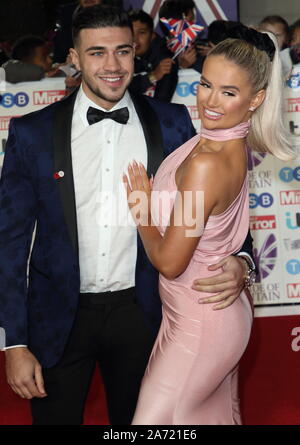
0 6 255 425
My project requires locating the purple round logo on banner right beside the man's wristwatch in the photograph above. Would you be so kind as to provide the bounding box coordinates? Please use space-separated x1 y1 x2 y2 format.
253 233 277 283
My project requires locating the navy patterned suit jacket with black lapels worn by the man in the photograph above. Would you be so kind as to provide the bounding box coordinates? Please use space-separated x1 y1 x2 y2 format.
0 92 252 367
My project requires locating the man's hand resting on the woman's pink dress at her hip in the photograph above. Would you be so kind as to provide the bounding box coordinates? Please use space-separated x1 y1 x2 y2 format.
192 256 246 310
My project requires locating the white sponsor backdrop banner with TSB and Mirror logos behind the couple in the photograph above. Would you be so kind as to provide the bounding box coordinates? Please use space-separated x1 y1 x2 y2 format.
0 70 300 316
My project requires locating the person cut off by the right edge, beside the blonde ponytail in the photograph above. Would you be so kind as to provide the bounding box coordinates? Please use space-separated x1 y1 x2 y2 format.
280 19 300 78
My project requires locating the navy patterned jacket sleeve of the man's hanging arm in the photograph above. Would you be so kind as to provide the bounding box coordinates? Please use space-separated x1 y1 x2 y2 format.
0 119 37 347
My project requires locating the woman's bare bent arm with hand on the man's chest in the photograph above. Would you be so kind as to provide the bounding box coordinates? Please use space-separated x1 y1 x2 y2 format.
124 153 220 279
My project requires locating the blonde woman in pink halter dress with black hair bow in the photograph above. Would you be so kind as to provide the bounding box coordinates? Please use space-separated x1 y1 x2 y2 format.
124 25 294 425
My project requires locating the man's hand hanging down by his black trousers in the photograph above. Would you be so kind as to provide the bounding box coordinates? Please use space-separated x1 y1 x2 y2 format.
5 347 47 399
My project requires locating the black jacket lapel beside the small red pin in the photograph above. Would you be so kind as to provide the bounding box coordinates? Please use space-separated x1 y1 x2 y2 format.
53 92 78 255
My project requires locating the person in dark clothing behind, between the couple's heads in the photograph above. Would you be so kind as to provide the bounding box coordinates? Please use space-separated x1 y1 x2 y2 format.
129 9 178 102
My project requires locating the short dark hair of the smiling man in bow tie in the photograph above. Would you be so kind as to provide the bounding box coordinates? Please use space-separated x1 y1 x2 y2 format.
72 5 132 44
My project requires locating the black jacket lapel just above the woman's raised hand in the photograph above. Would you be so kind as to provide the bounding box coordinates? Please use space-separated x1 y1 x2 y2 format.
131 95 164 176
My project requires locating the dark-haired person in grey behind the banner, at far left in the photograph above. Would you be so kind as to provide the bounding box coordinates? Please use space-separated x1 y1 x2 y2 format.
2 36 60 83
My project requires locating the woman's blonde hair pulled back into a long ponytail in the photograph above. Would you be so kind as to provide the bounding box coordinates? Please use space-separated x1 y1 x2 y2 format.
209 33 296 161
